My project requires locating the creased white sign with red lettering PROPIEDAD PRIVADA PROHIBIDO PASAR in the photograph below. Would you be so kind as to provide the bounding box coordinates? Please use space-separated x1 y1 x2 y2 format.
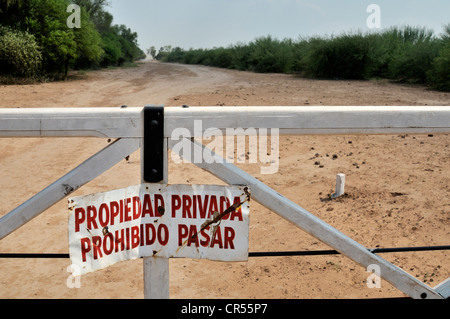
69 184 250 274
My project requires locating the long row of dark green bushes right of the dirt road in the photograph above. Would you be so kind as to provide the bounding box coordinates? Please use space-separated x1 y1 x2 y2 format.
154 24 450 91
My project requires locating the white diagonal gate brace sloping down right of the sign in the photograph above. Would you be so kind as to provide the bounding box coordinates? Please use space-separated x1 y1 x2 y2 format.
170 140 443 299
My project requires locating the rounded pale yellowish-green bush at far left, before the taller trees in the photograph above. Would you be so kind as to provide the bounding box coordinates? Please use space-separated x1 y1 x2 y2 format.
0 26 42 77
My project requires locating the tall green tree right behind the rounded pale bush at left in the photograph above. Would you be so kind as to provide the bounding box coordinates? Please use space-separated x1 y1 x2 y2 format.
0 0 102 75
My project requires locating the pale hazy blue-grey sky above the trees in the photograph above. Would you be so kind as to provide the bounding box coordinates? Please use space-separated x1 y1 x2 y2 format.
106 0 450 51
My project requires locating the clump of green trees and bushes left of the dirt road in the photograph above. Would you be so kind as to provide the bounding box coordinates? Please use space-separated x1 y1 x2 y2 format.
0 0 145 79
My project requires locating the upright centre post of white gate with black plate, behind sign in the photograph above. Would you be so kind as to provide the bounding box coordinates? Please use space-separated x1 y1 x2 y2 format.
141 106 170 299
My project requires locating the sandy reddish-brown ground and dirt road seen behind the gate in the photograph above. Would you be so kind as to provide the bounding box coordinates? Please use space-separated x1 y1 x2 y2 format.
0 63 450 299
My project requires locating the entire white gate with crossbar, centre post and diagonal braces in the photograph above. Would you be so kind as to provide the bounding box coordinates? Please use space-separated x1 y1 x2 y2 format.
0 106 450 299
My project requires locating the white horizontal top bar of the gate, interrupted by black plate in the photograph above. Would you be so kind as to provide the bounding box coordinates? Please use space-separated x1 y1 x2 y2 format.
0 106 450 138
